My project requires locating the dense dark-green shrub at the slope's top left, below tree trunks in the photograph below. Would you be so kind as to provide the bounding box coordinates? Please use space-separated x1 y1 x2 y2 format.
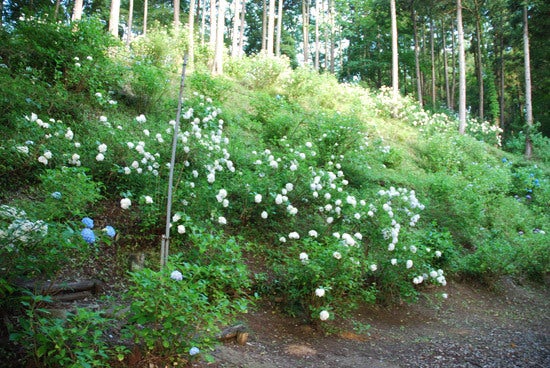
0 18 120 103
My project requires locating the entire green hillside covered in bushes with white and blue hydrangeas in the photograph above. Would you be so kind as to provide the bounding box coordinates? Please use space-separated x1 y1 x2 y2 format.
0 21 550 366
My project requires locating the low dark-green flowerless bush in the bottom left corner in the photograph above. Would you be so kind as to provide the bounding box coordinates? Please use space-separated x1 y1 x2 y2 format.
10 294 112 368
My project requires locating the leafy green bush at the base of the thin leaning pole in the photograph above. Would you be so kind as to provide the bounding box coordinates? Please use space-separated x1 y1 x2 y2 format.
124 231 249 360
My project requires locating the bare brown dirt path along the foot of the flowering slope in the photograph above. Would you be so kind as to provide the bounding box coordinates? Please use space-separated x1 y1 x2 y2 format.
203 280 550 368
